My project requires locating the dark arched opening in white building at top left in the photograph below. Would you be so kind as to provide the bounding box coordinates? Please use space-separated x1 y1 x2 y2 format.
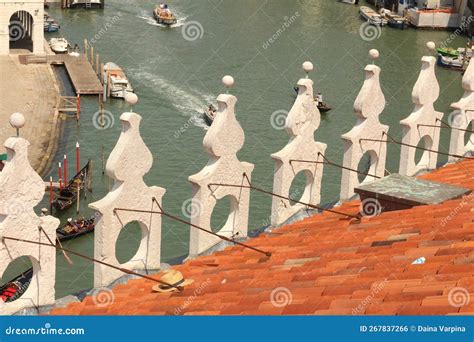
8 10 33 52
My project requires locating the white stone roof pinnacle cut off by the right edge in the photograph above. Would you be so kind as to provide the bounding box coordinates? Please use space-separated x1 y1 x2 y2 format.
447 59 474 162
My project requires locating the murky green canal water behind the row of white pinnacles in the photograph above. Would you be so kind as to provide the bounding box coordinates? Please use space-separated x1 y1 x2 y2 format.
13 0 466 297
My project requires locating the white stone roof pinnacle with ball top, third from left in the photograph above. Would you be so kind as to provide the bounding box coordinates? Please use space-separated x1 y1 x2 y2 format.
189 76 254 257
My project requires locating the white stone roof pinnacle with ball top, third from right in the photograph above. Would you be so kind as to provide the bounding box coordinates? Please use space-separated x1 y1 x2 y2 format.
341 49 388 201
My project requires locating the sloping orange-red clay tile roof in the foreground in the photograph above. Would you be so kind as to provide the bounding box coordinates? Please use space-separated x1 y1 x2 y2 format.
52 160 474 315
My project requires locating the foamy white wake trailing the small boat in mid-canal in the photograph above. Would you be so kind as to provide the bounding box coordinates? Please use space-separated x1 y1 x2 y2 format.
129 69 215 130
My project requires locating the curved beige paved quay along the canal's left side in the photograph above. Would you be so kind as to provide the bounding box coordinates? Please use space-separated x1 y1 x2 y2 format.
0 54 60 174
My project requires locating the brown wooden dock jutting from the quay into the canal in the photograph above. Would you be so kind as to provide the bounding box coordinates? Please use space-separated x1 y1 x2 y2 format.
47 54 103 95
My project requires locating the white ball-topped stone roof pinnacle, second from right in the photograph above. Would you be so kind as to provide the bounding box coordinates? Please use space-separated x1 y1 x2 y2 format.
399 42 443 176
